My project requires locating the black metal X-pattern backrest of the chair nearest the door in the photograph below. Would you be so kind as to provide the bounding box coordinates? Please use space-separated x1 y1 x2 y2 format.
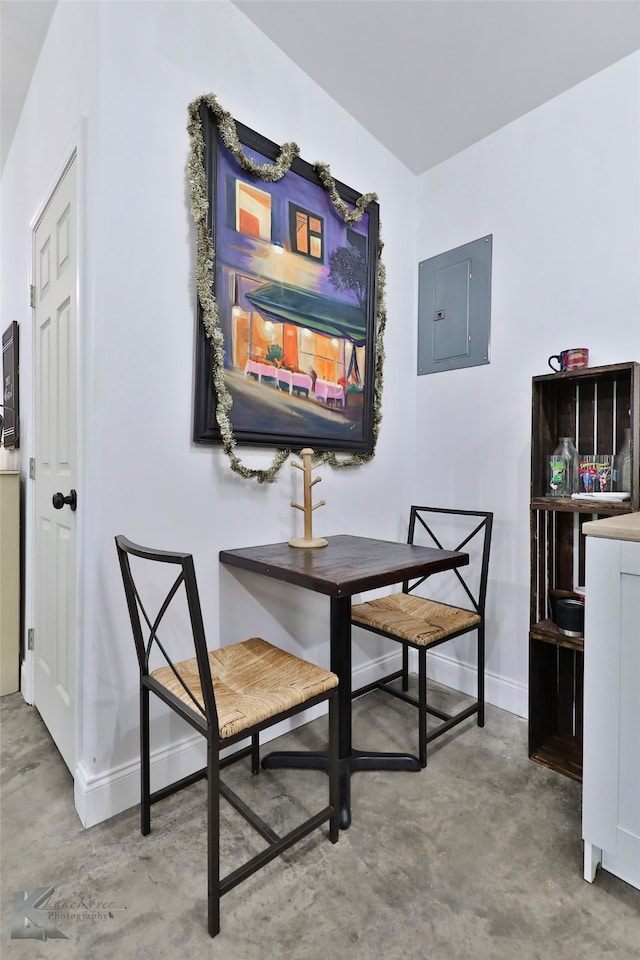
115 535 218 730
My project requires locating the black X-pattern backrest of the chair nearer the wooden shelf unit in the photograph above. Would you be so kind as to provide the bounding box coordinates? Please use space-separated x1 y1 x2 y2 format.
402 504 493 616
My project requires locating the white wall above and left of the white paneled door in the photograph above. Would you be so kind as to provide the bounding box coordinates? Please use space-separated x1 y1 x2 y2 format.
0 3 98 712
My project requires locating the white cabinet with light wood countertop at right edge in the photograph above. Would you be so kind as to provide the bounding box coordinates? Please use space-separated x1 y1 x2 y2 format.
582 513 640 889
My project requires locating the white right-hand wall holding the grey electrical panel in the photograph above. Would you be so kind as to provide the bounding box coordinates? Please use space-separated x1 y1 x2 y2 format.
413 53 640 714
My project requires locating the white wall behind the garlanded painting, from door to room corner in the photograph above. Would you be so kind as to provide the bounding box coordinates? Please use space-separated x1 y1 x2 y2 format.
3 2 415 824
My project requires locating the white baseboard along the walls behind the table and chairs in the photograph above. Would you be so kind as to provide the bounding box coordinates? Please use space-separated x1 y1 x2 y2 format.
74 653 528 827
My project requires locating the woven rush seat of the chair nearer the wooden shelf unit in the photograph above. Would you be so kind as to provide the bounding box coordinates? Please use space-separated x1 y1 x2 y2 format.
351 593 480 647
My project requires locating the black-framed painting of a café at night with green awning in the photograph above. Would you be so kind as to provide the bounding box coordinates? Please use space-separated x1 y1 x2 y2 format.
193 105 379 453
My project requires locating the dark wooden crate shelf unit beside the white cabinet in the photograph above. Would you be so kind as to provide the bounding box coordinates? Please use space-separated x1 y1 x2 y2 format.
529 362 640 780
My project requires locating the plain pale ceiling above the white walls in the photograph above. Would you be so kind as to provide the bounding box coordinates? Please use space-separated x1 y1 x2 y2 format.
0 0 640 173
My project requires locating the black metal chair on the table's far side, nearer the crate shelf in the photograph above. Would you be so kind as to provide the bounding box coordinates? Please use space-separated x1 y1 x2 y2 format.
351 506 493 767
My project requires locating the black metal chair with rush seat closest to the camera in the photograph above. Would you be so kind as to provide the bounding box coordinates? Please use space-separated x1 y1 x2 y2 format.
116 536 339 937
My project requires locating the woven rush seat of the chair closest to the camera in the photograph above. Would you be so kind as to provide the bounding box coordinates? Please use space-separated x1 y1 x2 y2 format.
151 637 338 740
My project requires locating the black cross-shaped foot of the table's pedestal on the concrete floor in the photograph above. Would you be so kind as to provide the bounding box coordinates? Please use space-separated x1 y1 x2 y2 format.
262 750 421 830
